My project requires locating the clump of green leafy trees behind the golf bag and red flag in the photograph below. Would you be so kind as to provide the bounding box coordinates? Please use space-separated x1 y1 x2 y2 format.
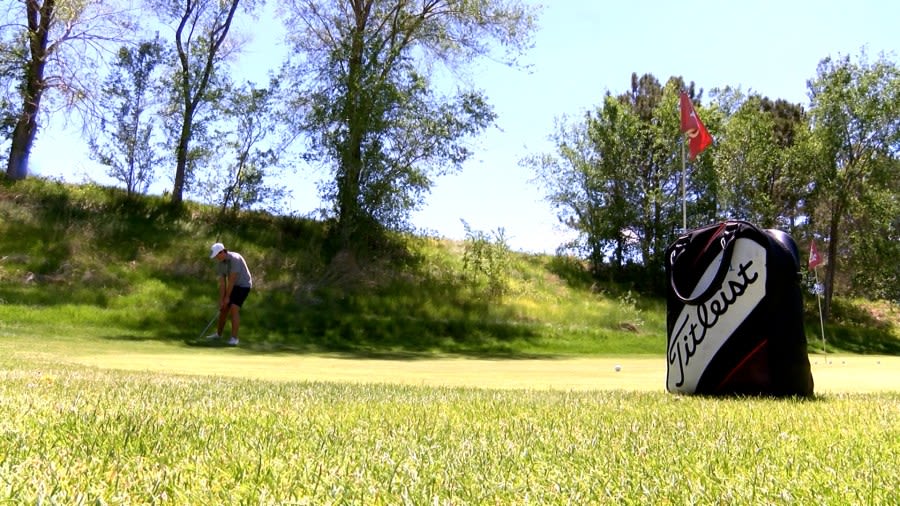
524 53 900 308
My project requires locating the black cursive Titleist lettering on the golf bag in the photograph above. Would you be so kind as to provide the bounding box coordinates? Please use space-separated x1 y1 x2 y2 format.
668 260 759 387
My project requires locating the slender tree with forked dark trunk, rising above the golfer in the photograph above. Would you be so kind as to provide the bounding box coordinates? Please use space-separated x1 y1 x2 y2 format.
151 0 253 204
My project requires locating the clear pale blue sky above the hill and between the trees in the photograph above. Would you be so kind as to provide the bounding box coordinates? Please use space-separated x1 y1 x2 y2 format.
31 0 900 252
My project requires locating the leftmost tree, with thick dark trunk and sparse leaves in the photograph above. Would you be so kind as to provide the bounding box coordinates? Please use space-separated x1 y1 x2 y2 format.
4 0 132 179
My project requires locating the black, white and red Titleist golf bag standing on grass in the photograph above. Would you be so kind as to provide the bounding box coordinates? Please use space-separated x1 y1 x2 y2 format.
666 221 813 396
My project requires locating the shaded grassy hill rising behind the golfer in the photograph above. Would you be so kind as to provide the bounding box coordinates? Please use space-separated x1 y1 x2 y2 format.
0 179 900 357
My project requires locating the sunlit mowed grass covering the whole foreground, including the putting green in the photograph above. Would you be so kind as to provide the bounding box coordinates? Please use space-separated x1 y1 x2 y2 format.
0 329 900 505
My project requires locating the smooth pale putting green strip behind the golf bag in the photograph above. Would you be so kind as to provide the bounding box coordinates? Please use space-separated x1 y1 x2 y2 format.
67 348 900 393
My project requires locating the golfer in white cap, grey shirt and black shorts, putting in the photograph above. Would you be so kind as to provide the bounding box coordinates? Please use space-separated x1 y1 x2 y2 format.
206 242 253 346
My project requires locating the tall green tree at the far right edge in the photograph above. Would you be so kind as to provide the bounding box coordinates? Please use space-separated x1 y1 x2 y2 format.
808 53 900 317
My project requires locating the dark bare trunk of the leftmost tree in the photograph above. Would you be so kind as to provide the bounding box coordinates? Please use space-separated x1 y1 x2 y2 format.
6 0 56 179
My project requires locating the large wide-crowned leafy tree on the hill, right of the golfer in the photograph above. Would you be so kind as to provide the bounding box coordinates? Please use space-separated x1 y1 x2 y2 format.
284 0 534 252
